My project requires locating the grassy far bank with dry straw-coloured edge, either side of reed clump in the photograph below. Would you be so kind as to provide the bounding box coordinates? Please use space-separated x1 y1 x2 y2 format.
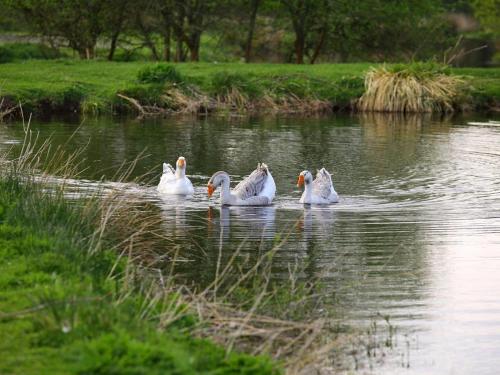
0 60 500 116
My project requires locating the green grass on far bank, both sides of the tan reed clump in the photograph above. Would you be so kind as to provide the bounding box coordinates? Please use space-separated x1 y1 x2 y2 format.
0 60 500 114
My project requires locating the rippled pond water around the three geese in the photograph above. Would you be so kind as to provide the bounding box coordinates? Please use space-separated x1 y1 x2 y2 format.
0 115 500 374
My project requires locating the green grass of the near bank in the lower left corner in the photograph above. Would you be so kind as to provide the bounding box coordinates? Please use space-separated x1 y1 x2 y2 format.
0 172 280 375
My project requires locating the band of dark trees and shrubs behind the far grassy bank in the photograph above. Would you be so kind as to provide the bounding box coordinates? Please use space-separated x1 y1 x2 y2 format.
0 0 499 66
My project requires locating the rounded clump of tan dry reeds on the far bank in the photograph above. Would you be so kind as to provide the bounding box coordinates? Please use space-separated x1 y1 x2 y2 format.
357 63 468 113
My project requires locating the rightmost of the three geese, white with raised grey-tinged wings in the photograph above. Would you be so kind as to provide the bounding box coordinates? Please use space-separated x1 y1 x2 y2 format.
297 168 339 204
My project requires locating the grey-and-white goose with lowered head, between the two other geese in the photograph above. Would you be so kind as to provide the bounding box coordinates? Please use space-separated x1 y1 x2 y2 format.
208 163 276 206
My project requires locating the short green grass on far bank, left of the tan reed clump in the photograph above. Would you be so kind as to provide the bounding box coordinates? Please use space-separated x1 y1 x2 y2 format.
0 60 369 114
